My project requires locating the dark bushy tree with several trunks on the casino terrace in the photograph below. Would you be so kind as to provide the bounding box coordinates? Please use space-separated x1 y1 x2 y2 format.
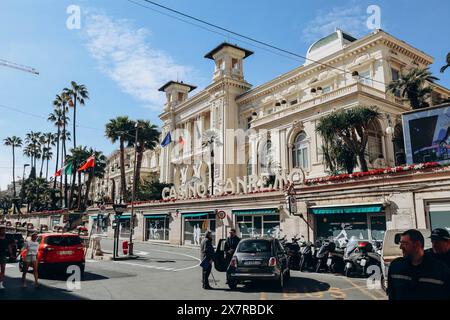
316 106 381 172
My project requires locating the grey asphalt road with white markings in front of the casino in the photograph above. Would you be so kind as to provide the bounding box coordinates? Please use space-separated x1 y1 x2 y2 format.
0 240 386 300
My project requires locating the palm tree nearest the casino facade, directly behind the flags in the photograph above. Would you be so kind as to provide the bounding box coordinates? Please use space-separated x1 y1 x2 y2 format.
133 120 160 192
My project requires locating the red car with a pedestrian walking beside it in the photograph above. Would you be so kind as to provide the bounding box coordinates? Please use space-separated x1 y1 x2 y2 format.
19 233 85 275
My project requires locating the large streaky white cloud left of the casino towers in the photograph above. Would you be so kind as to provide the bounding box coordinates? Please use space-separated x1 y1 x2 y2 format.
84 13 193 111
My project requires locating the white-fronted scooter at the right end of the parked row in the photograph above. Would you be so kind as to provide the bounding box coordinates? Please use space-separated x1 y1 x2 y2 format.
344 237 381 277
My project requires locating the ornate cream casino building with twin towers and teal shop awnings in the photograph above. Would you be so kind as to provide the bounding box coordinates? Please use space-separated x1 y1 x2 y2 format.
10 30 450 246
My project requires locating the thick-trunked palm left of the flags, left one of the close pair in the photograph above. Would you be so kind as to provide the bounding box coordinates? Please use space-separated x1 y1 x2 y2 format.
105 116 135 200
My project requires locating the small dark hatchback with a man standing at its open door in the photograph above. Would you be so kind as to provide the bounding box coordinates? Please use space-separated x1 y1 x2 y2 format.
223 238 290 289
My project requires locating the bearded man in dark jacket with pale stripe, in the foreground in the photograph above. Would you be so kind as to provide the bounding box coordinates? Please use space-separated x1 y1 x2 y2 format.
387 229 450 300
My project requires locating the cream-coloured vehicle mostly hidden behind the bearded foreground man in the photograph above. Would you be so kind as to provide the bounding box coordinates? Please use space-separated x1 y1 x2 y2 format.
381 229 431 290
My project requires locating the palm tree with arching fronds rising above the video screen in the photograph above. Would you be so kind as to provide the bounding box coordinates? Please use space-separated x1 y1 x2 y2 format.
387 68 439 110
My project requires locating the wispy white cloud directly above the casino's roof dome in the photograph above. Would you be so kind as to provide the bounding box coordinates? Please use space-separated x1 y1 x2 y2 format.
302 2 369 44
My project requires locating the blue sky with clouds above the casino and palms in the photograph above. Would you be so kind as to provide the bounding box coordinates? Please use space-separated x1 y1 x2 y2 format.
0 0 450 189
